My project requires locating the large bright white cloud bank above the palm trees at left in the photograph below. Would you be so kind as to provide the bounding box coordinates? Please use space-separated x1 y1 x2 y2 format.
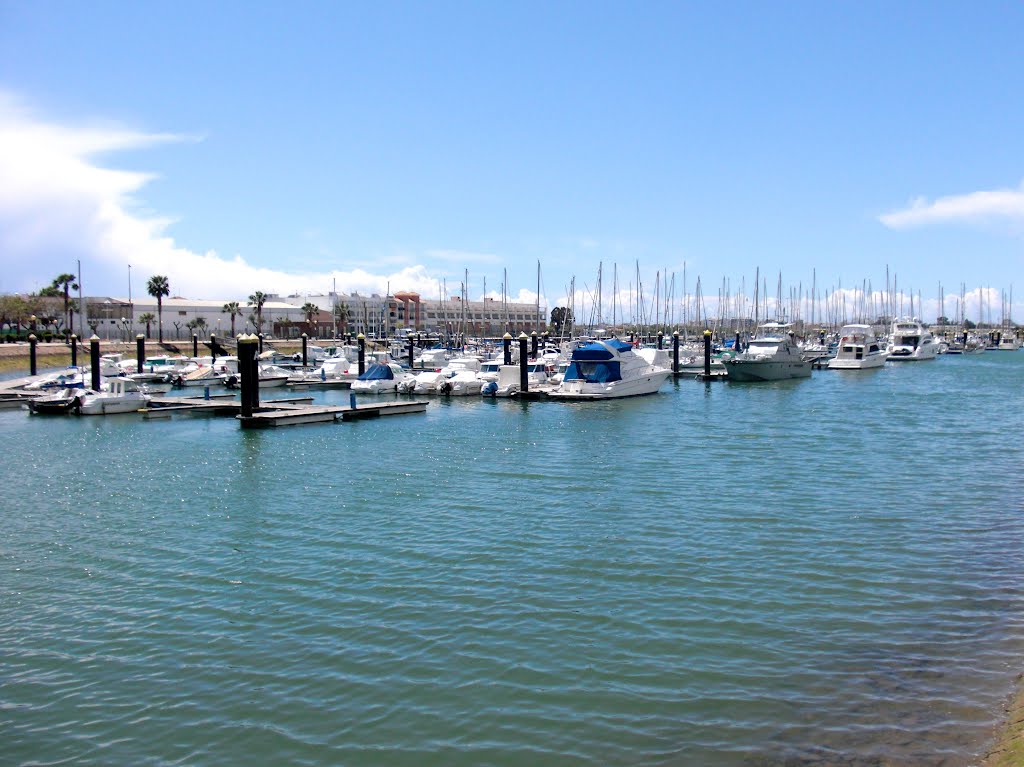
0 90 475 299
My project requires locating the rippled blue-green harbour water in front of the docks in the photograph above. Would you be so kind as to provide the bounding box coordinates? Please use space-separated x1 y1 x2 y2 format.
0 352 1024 765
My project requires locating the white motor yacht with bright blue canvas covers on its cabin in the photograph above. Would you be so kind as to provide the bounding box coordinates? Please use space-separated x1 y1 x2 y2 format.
548 339 672 399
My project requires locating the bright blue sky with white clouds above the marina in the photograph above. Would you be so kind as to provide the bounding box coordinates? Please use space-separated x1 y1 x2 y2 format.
0 0 1024 322
